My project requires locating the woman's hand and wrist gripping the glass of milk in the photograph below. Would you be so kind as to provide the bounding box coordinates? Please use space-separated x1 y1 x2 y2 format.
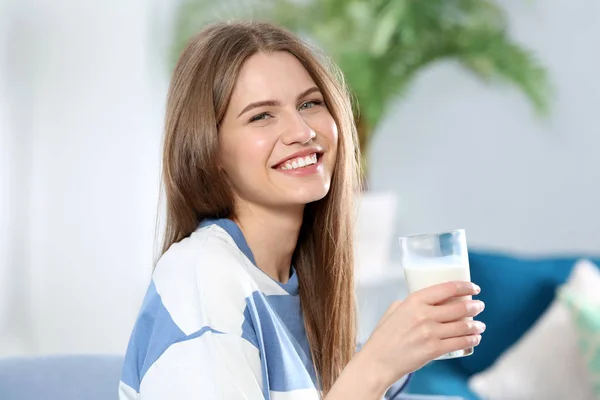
356 282 485 387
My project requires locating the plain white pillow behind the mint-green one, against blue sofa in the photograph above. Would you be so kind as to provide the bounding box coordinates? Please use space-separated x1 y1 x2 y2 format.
469 260 600 400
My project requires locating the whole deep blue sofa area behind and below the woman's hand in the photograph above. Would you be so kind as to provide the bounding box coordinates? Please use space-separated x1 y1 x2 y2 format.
408 251 600 400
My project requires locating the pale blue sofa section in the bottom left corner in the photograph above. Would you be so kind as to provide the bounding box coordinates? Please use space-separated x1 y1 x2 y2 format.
0 355 123 400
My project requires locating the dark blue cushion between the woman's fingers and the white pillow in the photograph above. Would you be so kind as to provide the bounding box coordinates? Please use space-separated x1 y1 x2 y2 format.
445 251 598 375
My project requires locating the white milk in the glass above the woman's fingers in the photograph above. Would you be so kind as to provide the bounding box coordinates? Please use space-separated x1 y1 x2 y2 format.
404 258 471 293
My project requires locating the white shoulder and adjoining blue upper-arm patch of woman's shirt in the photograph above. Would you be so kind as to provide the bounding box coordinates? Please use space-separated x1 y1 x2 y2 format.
123 226 254 389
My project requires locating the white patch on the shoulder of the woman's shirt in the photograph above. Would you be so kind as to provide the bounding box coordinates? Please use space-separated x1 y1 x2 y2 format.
153 226 258 336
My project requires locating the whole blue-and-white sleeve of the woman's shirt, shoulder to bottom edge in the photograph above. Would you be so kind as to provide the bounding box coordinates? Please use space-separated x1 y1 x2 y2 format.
119 231 265 400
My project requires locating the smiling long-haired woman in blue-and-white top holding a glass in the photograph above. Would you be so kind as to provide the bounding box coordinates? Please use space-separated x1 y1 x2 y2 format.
120 23 483 400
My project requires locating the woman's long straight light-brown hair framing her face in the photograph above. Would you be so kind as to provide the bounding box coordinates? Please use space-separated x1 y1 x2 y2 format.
162 22 359 394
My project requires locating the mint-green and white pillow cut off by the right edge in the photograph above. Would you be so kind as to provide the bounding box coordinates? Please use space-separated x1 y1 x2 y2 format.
559 287 600 399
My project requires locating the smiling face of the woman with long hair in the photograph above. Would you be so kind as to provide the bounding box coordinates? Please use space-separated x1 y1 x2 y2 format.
219 52 338 211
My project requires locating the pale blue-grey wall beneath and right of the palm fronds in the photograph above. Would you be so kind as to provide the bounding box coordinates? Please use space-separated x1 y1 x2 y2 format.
370 0 600 254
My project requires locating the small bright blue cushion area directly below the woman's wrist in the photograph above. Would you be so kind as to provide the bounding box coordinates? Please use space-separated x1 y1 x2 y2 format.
407 360 480 400
